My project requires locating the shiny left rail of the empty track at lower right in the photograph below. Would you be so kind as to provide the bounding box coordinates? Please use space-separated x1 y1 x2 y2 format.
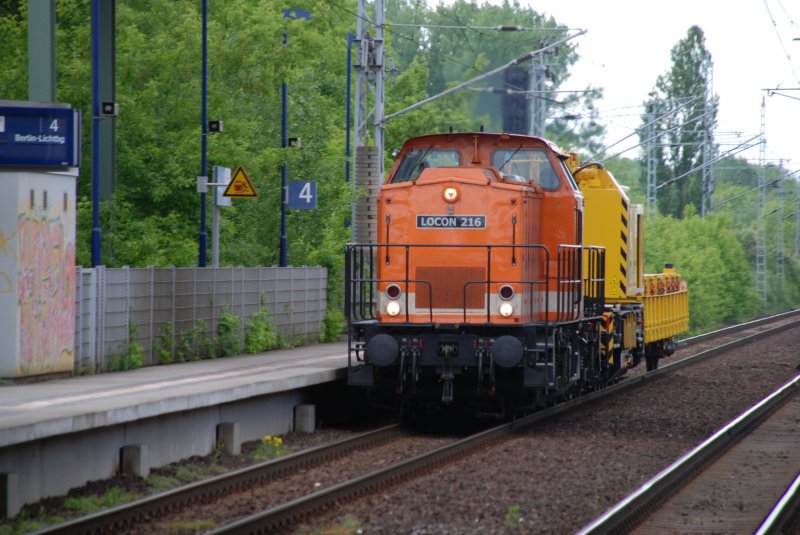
577 375 800 535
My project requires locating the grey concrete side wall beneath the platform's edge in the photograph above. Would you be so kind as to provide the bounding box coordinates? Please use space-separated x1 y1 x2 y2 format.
0 389 314 516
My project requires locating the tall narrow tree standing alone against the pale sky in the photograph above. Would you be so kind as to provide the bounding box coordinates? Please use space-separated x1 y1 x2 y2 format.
639 26 719 217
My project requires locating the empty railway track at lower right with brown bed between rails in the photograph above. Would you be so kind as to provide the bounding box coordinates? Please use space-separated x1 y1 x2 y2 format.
579 375 800 535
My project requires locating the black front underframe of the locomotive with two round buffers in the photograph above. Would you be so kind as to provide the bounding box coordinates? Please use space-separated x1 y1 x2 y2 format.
351 322 603 408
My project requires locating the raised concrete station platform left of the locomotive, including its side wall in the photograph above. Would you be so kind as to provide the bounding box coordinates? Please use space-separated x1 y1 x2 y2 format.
0 343 347 516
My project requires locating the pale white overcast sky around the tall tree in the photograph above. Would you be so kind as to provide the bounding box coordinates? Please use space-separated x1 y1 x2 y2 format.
536 0 800 170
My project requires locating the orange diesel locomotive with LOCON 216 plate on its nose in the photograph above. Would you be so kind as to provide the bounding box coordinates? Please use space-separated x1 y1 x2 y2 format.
345 132 688 414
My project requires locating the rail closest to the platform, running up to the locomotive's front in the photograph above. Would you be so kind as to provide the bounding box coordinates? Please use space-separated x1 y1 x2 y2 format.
35 424 403 534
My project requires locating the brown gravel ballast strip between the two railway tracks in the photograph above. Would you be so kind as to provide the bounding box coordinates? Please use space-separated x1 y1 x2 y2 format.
297 330 800 535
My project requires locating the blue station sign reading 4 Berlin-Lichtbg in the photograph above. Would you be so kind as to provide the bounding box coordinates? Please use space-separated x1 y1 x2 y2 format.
0 106 81 167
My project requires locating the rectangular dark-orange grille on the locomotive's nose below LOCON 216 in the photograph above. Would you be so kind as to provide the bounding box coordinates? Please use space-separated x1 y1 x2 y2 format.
415 267 486 310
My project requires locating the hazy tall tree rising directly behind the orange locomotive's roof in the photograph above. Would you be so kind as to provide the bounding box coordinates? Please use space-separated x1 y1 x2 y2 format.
387 0 604 153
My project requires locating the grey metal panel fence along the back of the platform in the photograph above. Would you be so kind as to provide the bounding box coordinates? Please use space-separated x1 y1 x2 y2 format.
75 266 328 372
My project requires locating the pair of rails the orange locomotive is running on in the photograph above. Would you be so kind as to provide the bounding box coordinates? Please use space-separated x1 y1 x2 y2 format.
37 315 800 533
